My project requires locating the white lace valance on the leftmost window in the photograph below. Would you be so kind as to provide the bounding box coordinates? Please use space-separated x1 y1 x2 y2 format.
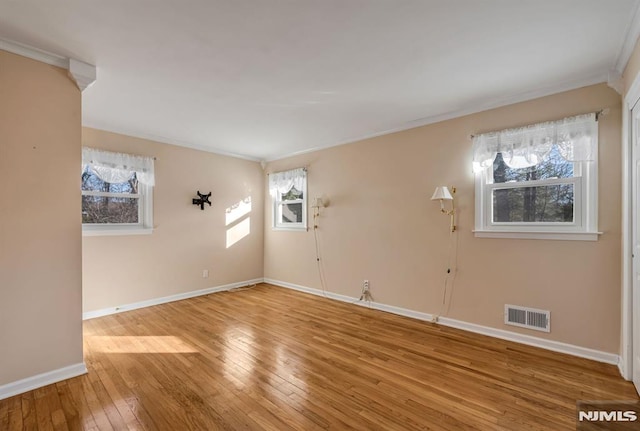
82 147 155 186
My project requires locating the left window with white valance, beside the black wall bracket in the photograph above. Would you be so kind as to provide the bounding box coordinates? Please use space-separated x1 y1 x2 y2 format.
81 148 154 235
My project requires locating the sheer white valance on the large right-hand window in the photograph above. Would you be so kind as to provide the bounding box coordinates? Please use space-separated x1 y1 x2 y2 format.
473 114 598 172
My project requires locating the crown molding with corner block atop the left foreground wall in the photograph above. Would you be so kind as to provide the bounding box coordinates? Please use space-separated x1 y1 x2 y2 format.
0 39 97 91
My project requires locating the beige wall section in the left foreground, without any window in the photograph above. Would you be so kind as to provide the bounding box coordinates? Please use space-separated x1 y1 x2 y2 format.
0 50 82 386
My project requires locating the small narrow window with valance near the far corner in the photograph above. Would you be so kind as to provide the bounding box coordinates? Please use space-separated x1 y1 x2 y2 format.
269 168 307 230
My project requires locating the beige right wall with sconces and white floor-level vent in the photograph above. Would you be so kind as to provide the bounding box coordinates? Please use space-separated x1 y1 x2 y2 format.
265 84 621 354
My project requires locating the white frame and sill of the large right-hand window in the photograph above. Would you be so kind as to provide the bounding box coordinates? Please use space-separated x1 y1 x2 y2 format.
474 125 602 241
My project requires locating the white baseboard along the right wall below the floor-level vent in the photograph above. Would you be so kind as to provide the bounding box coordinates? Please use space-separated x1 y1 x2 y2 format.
264 278 620 367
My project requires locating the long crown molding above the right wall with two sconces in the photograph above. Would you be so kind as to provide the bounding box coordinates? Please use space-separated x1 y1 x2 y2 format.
265 72 609 162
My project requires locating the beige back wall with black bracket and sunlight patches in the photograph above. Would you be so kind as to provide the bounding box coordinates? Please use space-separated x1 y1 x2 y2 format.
82 128 264 312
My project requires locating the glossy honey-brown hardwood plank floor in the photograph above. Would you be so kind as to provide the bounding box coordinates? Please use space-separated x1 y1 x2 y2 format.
0 284 638 431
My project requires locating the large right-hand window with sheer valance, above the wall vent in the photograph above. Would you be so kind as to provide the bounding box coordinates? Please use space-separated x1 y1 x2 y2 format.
473 114 598 240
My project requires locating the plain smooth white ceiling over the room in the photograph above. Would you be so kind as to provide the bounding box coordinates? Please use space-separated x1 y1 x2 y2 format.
0 0 638 160
